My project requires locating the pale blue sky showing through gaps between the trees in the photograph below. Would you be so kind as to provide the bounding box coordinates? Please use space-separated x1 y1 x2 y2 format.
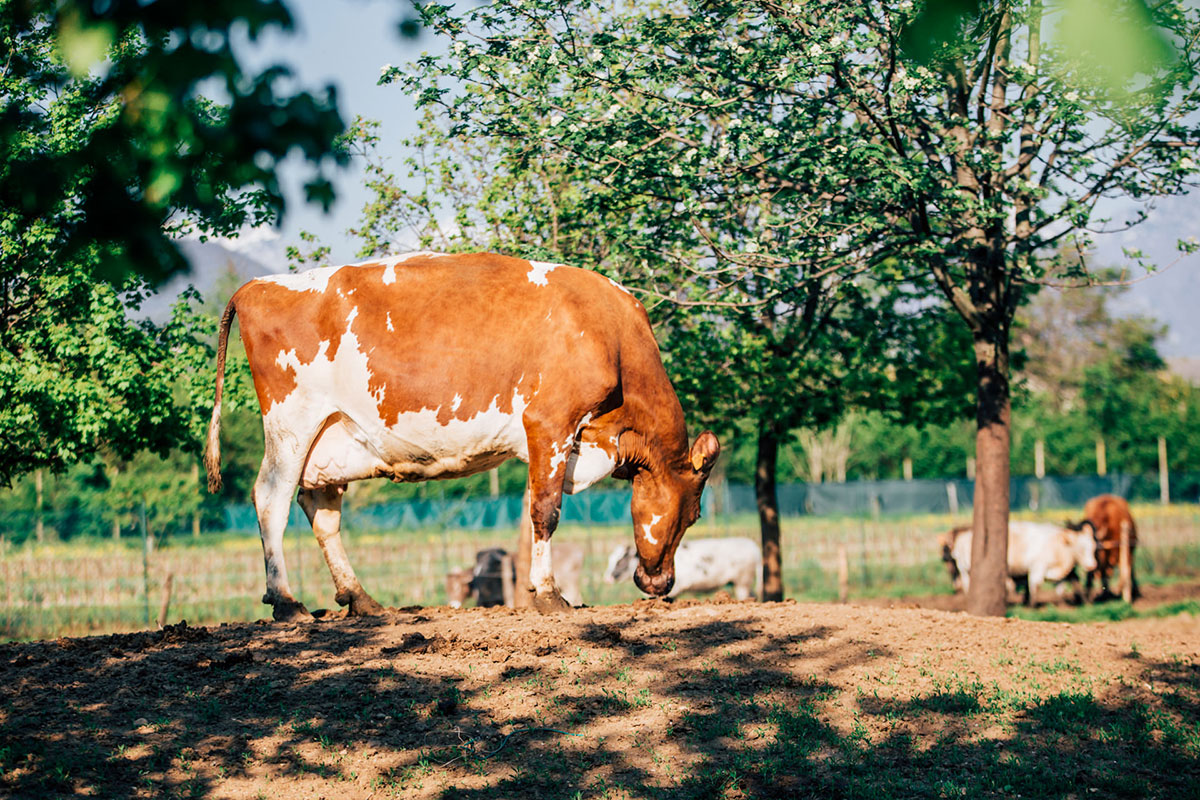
226 0 1200 356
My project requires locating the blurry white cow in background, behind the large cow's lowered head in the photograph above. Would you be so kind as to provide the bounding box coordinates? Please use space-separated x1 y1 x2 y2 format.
604 537 762 600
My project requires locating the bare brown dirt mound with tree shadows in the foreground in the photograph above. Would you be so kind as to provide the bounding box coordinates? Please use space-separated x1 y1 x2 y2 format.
0 596 1200 800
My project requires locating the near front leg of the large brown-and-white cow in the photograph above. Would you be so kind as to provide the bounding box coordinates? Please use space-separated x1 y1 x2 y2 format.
528 435 575 614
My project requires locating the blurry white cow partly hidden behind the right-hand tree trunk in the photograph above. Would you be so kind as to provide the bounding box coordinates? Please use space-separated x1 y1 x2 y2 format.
953 522 1096 606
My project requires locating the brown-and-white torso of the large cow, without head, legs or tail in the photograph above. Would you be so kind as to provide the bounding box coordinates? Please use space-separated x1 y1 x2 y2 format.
226 253 667 487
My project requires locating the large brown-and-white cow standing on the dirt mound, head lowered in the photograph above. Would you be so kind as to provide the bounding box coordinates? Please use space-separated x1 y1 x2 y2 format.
204 253 720 620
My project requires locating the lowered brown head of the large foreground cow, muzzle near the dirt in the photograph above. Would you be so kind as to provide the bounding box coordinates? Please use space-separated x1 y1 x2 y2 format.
631 431 721 596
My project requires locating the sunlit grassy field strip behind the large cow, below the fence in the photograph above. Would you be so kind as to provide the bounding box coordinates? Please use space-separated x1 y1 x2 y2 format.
0 505 1200 640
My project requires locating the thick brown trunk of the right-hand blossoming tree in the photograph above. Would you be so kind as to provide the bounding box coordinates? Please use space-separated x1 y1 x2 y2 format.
967 326 1012 616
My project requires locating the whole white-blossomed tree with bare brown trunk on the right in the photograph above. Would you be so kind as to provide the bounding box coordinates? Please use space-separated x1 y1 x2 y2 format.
385 0 1200 614
